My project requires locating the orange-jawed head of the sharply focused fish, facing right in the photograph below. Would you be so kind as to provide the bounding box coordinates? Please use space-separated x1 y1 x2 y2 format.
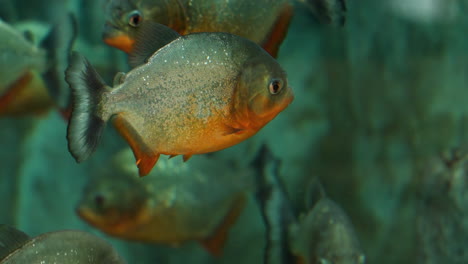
234 53 294 128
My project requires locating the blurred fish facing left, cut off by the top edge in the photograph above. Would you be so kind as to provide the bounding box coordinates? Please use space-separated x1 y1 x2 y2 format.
103 0 292 56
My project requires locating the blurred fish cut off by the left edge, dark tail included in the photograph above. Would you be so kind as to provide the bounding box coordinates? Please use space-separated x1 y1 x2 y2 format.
0 14 77 116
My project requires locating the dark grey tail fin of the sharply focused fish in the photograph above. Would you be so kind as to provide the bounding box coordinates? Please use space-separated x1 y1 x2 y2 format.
65 52 107 162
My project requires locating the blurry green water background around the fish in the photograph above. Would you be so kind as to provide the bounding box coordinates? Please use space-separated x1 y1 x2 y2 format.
0 0 468 264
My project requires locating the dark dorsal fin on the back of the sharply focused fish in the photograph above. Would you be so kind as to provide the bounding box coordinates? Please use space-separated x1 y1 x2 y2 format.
128 21 180 68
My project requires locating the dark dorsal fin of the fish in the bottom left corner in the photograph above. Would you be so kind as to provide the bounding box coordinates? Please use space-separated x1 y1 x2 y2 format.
0 225 29 261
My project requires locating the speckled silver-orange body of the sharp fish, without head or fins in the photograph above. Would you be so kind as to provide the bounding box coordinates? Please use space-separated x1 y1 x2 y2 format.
108 34 280 155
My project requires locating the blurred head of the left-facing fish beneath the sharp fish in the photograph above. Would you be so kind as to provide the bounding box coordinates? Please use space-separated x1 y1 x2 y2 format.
76 171 149 234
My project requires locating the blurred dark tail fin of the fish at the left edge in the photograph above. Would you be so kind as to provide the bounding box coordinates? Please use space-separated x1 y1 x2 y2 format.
41 13 77 112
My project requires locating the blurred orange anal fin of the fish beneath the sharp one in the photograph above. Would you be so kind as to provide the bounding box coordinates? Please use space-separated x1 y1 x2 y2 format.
200 194 246 256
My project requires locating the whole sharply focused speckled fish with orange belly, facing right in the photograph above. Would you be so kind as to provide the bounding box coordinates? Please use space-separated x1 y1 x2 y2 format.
66 23 294 176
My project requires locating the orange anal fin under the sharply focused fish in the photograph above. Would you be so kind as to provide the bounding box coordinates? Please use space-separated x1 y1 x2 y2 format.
113 115 159 176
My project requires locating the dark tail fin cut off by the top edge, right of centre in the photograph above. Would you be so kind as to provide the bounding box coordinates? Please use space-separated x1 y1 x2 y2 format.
297 0 347 26
